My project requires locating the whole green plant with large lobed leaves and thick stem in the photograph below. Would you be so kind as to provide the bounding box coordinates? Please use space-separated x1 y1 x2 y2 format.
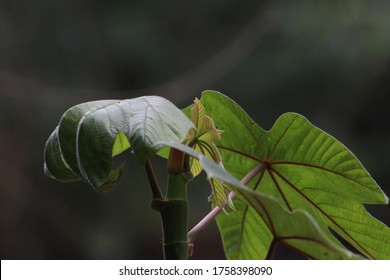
44 91 390 259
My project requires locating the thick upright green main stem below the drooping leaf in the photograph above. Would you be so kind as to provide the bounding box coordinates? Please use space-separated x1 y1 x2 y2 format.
160 173 188 260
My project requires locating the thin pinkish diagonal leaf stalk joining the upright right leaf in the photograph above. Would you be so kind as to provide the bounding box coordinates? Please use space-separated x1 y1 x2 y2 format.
187 163 267 247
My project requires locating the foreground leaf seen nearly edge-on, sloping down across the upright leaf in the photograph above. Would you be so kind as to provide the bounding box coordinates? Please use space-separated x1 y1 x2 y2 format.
159 142 360 259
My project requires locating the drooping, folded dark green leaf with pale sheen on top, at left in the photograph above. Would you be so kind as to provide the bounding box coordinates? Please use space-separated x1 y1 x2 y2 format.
44 96 193 191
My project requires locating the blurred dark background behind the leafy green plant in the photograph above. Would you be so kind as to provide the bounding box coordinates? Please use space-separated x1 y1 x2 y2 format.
0 0 390 259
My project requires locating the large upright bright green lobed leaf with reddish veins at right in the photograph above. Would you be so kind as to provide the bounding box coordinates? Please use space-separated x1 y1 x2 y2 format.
201 91 390 259
